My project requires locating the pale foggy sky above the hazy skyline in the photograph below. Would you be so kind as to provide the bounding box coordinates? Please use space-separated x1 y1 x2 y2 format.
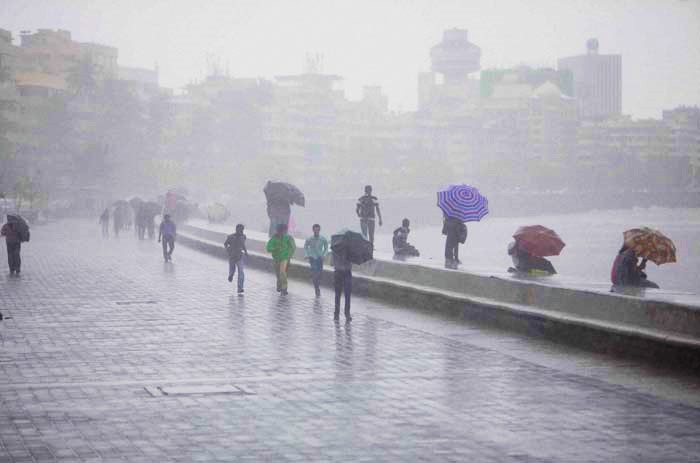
0 0 700 118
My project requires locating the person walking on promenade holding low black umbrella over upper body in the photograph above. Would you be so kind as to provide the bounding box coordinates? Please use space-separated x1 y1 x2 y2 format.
331 230 374 322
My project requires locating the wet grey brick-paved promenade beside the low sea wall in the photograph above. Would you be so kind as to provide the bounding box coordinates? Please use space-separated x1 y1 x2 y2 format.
0 221 700 463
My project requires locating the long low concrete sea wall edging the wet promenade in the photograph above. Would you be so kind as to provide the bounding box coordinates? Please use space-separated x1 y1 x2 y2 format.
178 225 700 370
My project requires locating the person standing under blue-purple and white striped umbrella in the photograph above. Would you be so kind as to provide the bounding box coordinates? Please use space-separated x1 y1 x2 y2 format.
437 184 489 269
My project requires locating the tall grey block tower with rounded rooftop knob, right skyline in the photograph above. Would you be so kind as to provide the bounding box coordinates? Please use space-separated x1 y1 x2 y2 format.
558 39 622 119
